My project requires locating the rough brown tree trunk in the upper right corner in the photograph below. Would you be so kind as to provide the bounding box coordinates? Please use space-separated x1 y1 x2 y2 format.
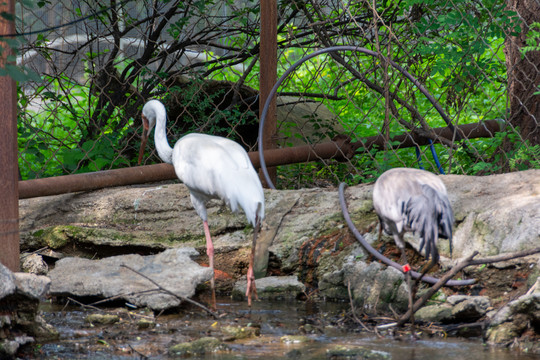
505 0 540 145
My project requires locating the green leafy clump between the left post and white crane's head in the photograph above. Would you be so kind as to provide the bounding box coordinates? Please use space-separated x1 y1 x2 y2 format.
18 78 136 179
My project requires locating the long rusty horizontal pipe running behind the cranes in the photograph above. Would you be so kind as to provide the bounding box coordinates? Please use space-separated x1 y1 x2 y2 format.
19 120 501 199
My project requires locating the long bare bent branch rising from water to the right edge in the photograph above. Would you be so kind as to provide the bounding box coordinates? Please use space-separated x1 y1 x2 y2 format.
397 247 540 326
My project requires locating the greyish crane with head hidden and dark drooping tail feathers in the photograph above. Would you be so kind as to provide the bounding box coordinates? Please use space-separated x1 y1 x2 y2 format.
373 168 454 325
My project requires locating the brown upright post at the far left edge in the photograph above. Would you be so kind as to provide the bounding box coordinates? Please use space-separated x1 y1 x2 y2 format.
0 0 20 271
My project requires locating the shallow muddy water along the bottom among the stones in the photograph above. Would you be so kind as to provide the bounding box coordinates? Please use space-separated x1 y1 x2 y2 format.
31 298 540 360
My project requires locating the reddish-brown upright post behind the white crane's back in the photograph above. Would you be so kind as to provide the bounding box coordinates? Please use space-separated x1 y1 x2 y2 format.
259 0 277 187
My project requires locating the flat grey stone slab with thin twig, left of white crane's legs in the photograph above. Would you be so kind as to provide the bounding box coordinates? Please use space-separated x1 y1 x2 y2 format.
49 248 212 311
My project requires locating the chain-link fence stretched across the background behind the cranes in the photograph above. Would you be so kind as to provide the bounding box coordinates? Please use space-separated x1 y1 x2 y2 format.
18 0 540 188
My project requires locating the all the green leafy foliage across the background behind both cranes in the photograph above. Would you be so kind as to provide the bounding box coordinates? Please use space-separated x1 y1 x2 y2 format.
14 0 540 187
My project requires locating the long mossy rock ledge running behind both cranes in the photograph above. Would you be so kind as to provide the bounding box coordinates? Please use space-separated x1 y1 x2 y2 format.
19 170 540 308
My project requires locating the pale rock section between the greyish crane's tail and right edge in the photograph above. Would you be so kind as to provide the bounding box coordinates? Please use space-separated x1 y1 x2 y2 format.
442 170 540 258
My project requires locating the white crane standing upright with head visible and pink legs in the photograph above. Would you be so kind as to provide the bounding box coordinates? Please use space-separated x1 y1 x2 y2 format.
139 100 264 306
